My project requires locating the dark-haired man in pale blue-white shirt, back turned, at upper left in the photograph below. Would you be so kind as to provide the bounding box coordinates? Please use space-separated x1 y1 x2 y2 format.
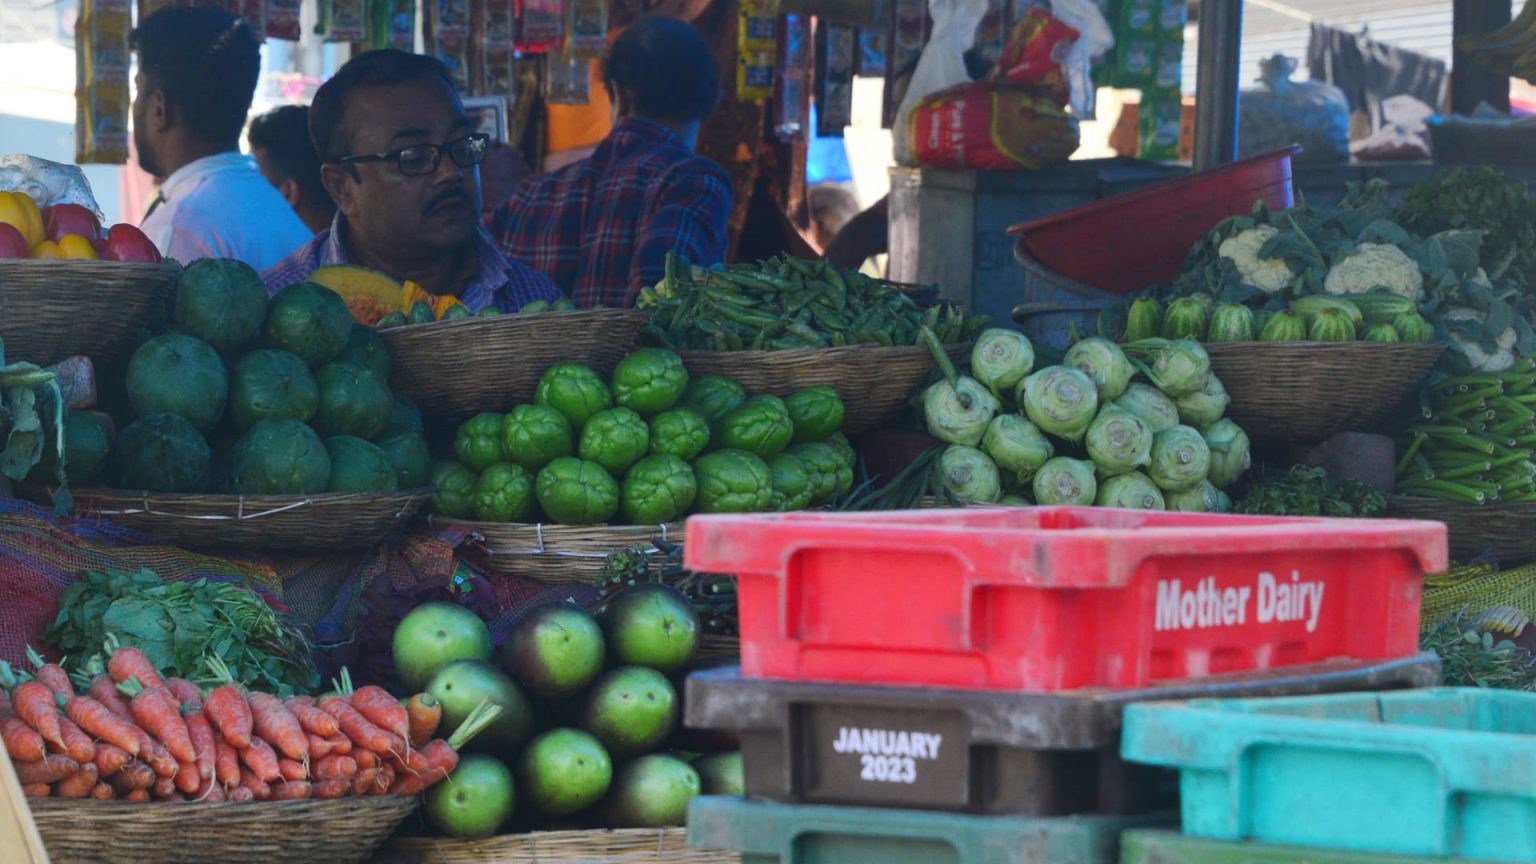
132 6 310 271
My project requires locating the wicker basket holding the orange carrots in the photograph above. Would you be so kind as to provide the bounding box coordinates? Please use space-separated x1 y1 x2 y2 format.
29 798 419 864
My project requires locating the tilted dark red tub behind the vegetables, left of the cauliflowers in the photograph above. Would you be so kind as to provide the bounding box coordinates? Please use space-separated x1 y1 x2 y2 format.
1008 148 1299 294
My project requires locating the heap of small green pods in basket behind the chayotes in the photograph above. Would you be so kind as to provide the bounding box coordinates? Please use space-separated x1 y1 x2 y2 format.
639 254 986 351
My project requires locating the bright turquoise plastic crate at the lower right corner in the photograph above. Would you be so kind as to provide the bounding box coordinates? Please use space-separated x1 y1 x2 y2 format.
1121 689 1536 861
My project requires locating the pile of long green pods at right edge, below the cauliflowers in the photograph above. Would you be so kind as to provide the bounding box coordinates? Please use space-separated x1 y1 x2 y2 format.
1398 358 1536 504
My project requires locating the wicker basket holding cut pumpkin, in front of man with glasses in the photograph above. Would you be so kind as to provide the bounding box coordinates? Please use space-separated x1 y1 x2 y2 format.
379 309 650 420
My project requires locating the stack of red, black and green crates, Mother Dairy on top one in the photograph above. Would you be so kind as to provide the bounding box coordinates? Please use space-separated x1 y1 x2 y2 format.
684 507 1445 864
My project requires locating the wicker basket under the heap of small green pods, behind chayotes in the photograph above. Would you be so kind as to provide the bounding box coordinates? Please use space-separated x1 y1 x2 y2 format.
679 343 971 435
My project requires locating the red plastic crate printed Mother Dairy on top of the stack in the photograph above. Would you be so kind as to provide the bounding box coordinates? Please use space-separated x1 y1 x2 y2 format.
685 507 1445 692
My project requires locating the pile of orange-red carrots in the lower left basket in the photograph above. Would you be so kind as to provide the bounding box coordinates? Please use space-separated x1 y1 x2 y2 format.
0 647 501 801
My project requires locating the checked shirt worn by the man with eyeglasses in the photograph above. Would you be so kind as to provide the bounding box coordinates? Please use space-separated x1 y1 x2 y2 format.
261 212 561 312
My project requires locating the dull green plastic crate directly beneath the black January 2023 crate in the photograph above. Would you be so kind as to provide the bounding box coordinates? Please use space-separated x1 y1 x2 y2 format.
688 796 1172 864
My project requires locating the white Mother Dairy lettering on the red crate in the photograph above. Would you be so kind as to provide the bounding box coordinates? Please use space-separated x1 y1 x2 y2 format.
1154 570 1327 633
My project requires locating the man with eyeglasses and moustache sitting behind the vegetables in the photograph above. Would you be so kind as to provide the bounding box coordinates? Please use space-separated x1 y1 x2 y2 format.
263 51 561 312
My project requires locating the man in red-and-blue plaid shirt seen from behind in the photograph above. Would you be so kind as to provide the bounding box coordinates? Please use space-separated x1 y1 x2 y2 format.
492 17 731 306
